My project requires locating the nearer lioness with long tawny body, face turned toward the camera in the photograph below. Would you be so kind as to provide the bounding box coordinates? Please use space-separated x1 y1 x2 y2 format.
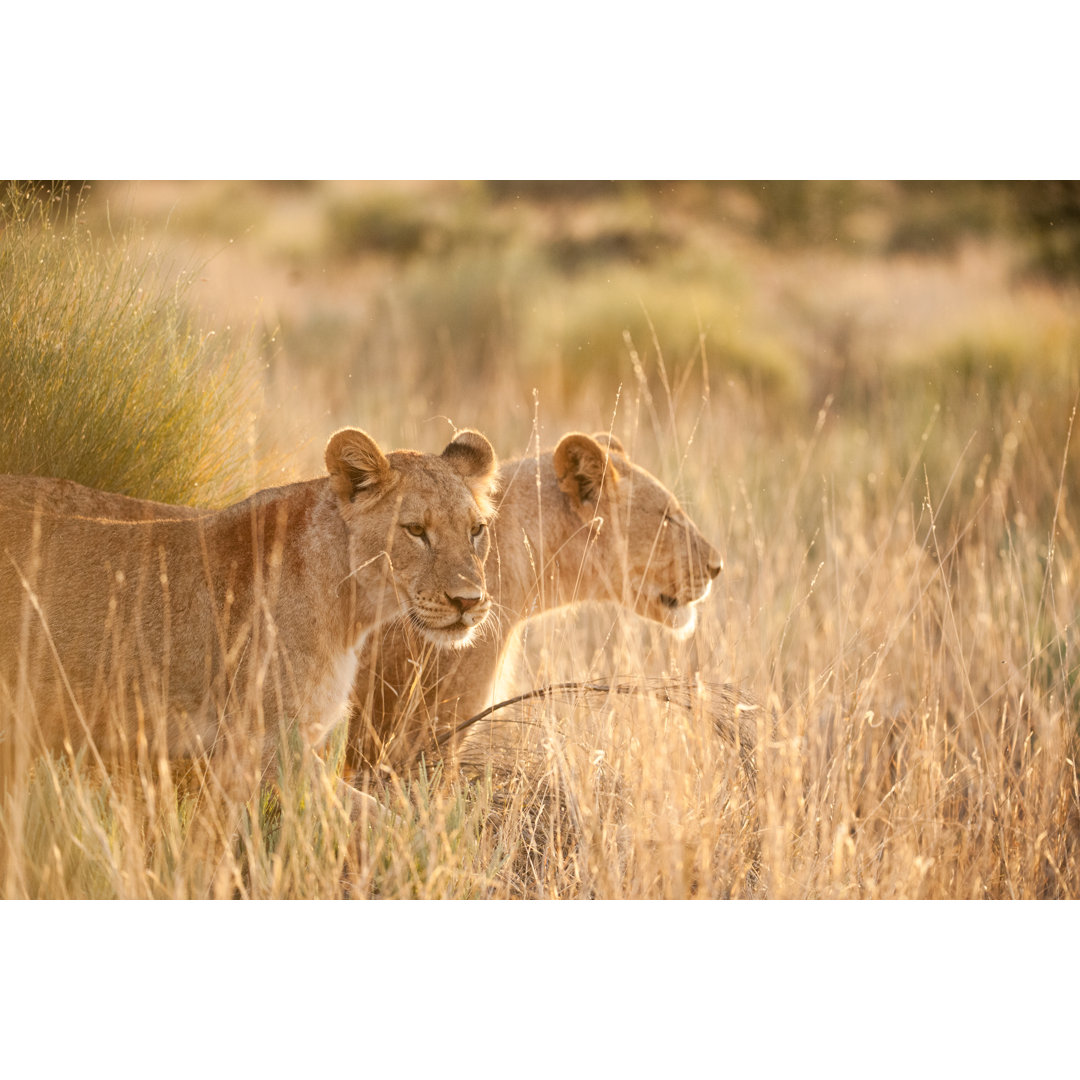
0 429 496 786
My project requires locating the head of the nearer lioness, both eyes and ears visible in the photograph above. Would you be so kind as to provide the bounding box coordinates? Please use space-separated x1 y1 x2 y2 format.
326 428 496 647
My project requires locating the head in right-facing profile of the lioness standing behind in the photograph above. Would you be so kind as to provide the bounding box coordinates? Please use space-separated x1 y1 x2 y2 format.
553 432 724 634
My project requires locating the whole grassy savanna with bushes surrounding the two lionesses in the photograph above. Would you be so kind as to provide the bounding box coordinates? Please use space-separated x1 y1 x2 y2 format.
0 183 1080 899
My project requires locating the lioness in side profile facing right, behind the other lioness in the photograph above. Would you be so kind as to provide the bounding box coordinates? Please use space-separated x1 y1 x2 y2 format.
347 432 724 771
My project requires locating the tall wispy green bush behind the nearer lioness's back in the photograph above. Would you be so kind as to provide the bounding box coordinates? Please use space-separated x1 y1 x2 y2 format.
0 186 257 505
